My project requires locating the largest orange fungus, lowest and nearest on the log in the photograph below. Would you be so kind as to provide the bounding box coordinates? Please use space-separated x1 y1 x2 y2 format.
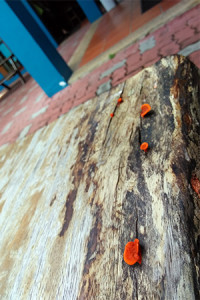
124 239 142 265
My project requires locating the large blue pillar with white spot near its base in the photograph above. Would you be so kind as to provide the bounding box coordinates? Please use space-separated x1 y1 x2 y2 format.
0 0 72 97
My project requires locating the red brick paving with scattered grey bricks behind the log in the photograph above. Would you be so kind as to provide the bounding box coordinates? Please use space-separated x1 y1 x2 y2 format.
0 5 200 145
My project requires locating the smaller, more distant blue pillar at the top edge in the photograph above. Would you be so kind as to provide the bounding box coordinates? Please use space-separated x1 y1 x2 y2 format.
76 0 102 23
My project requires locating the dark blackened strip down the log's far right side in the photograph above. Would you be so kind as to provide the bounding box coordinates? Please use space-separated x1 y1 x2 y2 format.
172 57 200 299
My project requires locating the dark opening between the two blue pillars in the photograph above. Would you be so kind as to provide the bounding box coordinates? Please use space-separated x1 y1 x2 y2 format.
28 0 86 44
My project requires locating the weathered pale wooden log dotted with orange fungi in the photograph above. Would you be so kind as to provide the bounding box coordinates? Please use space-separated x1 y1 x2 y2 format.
0 56 200 300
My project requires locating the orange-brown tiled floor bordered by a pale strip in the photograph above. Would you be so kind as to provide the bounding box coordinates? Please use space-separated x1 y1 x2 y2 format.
80 0 180 66
